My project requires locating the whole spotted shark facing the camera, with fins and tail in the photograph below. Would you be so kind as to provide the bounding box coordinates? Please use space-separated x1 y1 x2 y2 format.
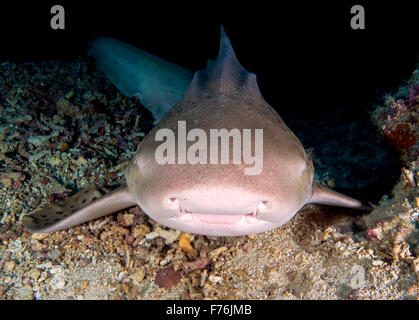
22 27 372 236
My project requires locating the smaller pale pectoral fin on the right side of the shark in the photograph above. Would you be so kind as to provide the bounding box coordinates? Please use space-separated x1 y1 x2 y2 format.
307 183 373 211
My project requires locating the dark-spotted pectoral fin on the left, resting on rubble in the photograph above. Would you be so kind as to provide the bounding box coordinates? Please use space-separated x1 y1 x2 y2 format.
22 187 136 233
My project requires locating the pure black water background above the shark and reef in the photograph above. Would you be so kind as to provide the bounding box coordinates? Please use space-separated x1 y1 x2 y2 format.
0 0 419 120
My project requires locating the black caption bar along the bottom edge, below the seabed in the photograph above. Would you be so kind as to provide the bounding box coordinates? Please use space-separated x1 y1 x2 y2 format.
0 300 415 320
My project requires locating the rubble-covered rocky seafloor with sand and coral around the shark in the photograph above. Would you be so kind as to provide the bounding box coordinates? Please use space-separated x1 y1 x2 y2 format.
0 58 419 299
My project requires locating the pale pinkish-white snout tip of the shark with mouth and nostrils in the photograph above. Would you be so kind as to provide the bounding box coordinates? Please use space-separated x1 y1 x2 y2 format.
138 185 288 236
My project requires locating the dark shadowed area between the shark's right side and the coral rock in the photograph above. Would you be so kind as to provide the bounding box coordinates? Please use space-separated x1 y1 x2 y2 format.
288 112 402 203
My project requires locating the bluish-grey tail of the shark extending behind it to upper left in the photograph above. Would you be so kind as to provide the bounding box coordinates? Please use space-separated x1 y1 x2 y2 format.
88 37 193 121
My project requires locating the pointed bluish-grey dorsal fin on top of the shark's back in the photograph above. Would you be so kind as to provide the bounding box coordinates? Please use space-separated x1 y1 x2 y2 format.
185 26 262 98
